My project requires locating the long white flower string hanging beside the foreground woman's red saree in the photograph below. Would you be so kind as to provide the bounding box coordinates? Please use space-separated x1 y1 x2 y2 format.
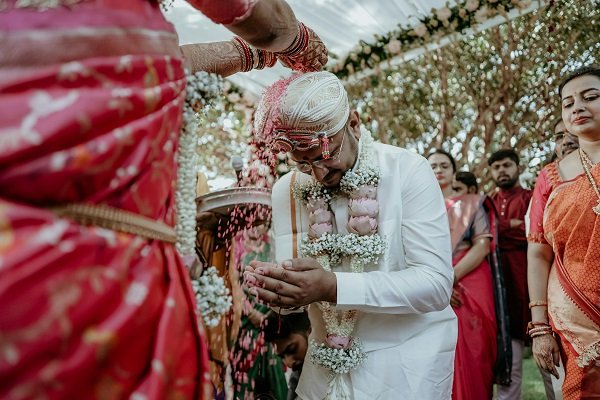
175 71 221 255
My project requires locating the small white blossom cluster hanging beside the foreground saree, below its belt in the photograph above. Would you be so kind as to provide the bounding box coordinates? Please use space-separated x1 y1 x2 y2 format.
192 267 233 327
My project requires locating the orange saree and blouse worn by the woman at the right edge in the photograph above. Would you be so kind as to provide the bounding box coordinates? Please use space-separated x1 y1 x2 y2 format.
529 164 600 400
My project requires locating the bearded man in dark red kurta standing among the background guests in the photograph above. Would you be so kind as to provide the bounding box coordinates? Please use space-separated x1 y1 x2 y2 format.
488 149 531 400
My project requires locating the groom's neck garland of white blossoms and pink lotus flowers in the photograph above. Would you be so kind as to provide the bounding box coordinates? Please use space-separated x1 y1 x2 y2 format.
292 130 386 400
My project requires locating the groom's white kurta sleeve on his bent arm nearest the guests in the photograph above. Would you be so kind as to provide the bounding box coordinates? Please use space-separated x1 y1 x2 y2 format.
336 158 453 314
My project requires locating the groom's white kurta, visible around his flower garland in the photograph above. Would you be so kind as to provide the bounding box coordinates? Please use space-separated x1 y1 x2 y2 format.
273 143 458 400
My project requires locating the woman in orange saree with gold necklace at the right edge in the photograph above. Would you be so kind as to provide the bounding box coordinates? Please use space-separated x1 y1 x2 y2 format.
528 67 600 400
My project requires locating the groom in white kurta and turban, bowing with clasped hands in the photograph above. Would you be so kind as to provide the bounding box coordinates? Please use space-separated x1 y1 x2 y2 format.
244 72 457 400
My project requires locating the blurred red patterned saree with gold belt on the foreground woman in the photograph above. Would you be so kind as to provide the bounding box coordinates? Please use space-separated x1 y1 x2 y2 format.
0 0 328 399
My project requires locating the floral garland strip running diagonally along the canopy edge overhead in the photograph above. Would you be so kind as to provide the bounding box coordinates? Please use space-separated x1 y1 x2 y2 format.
330 0 532 78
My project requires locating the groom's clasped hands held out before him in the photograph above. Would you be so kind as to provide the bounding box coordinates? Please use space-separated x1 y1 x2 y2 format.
244 258 337 308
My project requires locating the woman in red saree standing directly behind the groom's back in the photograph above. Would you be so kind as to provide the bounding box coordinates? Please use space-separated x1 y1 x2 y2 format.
427 149 508 400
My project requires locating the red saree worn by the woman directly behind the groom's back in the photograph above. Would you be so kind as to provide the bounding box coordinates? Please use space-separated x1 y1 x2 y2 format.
446 195 497 400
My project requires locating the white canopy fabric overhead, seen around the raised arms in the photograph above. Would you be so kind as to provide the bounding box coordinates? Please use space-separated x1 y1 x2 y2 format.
165 0 456 96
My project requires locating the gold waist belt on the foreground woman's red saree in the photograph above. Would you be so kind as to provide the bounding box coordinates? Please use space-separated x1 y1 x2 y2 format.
51 204 177 243
